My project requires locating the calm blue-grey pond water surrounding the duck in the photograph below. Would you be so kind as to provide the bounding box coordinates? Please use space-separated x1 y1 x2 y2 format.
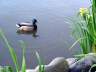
0 0 89 68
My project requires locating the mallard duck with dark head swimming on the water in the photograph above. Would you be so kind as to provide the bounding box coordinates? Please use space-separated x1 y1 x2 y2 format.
16 19 37 32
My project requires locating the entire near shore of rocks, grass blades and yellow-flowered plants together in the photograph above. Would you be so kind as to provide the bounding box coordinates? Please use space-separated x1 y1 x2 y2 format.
0 0 96 72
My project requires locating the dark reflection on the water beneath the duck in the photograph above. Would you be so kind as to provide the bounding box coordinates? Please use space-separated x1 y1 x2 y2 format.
16 29 39 38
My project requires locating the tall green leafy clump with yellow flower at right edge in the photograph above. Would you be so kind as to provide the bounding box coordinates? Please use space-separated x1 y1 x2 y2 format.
71 0 96 54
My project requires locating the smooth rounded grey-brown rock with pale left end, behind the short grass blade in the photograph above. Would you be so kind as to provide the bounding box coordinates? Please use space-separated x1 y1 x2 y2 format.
26 57 69 72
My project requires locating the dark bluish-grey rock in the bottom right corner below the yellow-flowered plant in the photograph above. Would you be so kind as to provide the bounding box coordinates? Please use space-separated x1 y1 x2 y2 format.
69 53 96 72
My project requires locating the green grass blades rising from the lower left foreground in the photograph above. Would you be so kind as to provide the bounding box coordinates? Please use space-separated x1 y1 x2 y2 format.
0 29 45 72
